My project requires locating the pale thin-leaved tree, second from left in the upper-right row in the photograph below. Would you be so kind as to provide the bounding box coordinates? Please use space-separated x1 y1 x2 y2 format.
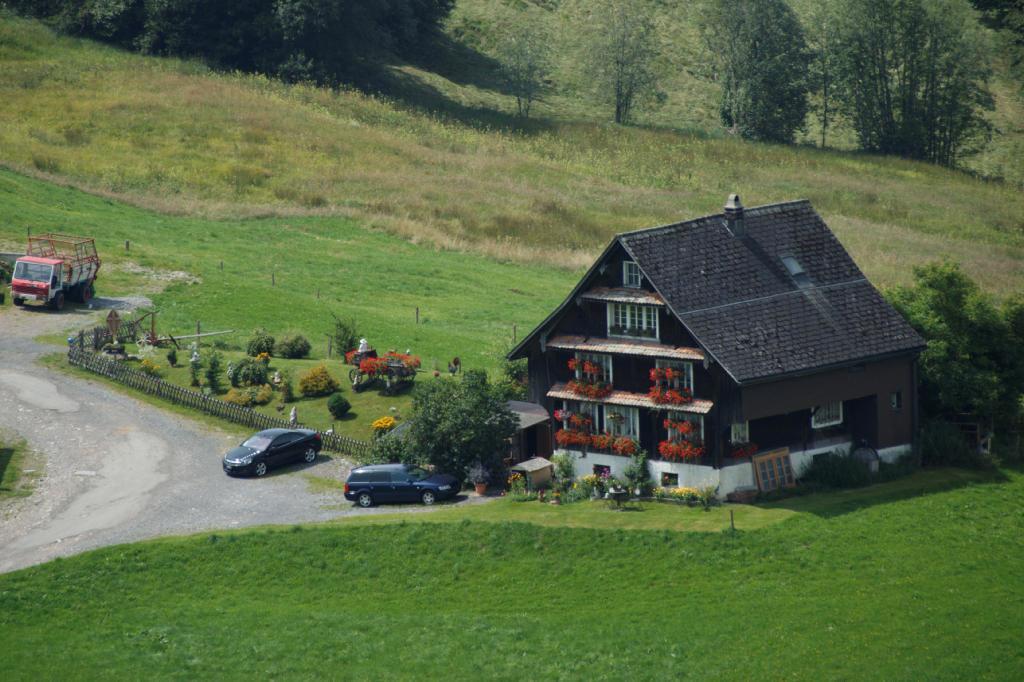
583 0 665 123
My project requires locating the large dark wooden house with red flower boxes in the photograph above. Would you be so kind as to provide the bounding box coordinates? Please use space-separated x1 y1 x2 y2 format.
509 195 924 495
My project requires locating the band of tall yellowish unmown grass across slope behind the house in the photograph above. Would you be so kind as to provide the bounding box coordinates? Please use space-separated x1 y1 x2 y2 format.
0 13 1024 296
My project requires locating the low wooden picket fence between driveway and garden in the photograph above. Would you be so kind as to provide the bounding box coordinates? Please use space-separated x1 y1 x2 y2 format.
68 346 371 461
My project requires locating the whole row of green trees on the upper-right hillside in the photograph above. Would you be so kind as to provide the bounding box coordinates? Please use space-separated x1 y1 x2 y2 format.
498 0 992 165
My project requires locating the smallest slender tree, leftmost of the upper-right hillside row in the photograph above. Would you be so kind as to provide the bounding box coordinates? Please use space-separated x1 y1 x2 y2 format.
497 17 551 118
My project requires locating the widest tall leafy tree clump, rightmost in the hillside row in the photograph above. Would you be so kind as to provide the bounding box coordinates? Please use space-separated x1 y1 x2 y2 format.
838 0 993 166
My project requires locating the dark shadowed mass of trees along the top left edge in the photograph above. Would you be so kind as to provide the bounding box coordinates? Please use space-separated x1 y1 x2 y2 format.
8 0 455 84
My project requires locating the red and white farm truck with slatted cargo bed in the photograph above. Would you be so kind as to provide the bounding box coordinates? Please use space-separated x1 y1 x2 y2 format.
10 235 99 310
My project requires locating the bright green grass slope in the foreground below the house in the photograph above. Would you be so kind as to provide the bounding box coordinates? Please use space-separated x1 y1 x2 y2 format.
0 464 1024 680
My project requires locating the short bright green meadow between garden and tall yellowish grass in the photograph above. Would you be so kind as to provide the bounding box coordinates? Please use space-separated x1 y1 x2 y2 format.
0 171 572 372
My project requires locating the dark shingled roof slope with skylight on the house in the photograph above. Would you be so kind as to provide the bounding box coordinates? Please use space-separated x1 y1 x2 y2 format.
618 201 924 382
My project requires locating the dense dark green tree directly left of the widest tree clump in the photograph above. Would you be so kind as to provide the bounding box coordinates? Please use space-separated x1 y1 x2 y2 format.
701 0 810 142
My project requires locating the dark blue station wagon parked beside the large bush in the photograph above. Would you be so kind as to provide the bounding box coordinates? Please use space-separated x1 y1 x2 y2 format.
345 464 459 507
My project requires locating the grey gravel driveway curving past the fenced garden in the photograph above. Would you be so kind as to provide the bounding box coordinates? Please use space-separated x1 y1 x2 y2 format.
0 299 484 571
